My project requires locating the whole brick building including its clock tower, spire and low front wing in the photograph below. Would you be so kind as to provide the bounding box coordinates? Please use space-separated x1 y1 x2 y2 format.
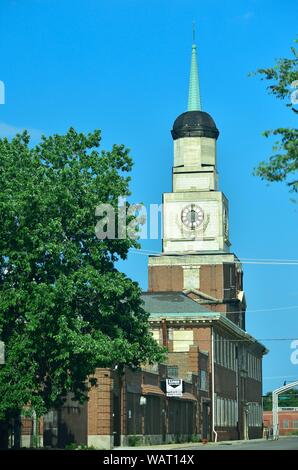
18 38 266 448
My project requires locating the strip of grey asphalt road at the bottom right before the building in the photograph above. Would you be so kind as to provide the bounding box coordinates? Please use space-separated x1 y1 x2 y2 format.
177 436 298 450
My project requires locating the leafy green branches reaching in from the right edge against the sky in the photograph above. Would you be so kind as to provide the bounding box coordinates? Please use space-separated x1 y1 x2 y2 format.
255 40 298 192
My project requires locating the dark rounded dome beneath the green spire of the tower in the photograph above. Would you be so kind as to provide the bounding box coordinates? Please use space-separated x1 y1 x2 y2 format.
171 111 219 140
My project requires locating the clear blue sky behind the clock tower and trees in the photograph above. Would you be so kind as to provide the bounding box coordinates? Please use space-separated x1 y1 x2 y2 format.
0 0 298 391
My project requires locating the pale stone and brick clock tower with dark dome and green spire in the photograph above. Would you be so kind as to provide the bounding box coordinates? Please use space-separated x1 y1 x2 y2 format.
149 38 245 328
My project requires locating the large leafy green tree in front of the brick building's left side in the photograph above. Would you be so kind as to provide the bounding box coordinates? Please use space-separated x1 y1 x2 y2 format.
0 128 162 436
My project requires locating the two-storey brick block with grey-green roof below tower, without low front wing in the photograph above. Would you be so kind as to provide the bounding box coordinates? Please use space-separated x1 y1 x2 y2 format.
143 292 266 440
